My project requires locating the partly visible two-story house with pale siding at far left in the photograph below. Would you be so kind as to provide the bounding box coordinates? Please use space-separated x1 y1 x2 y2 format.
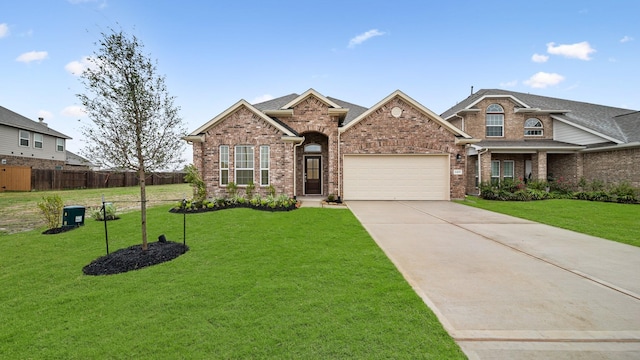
0 106 71 169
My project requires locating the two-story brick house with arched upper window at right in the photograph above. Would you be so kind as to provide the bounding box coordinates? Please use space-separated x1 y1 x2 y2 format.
441 89 640 194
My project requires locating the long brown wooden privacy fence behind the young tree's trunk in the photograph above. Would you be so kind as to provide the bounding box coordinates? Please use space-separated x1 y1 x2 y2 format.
27 169 185 191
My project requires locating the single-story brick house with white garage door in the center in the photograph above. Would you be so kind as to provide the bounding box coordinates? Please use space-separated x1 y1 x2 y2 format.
184 89 474 200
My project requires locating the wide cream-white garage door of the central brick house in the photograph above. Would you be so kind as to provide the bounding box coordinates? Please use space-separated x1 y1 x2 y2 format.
343 155 449 200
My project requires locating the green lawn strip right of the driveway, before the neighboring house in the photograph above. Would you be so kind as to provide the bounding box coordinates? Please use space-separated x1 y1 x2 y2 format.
458 197 640 246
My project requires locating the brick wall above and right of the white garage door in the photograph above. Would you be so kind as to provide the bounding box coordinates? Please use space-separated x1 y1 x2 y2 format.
340 97 466 199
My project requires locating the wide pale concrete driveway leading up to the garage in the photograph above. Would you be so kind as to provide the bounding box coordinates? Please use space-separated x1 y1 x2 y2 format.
347 201 640 359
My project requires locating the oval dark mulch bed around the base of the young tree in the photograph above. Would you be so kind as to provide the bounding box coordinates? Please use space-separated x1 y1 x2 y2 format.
82 241 189 275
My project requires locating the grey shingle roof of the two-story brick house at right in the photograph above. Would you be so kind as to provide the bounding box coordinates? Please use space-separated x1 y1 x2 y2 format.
442 89 639 143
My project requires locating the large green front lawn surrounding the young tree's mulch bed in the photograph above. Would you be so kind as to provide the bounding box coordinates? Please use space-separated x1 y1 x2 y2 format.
0 205 464 359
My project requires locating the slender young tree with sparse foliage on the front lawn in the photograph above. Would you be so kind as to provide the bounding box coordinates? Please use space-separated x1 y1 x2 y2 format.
78 30 186 250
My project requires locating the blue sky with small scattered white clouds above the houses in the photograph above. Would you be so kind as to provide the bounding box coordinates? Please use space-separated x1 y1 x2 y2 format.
0 0 640 161
